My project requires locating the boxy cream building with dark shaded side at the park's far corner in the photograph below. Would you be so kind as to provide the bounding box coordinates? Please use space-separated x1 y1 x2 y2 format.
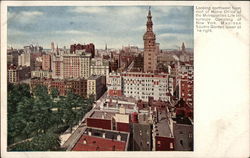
87 76 106 100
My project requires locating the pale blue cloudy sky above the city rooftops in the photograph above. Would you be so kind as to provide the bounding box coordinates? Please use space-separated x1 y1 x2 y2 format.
8 6 193 49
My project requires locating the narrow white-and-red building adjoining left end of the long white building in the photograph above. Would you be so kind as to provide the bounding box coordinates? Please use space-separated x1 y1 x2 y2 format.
107 72 122 96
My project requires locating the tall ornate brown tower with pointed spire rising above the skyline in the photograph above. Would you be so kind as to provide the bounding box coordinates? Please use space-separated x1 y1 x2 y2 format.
143 6 157 72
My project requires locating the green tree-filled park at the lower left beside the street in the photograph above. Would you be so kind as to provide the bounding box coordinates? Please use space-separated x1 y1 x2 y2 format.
7 84 94 151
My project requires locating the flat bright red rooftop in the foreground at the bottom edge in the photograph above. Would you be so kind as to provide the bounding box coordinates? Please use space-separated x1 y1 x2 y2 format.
72 135 126 151
